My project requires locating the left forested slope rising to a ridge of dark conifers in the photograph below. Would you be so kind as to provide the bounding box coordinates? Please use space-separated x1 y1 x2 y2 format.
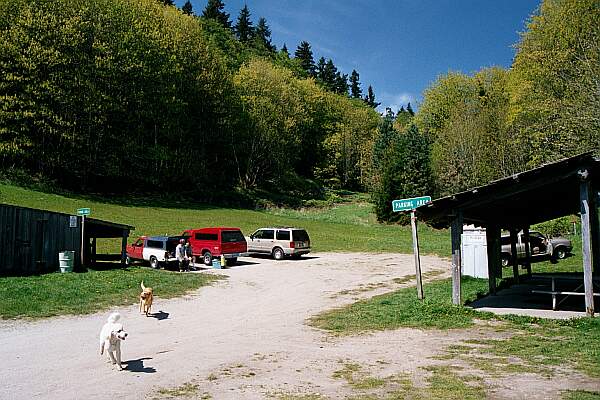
0 0 379 195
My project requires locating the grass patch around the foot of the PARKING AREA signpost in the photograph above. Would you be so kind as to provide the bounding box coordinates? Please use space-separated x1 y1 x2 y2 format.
310 278 489 334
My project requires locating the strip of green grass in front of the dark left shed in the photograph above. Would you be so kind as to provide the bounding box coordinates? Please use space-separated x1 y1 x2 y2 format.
0 267 218 318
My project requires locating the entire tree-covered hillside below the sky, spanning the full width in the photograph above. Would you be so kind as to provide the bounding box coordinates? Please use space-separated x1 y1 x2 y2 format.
0 0 600 220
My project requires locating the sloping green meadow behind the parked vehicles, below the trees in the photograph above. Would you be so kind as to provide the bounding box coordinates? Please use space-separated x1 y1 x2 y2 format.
0 184 450 257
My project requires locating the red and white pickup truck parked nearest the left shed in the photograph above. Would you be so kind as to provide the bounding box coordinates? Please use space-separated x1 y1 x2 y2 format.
125 236 184 269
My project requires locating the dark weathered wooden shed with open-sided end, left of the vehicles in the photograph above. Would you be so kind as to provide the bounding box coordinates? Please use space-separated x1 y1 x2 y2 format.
0 204 134 275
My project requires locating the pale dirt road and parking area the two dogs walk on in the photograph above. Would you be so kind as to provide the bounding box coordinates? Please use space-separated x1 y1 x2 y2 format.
0 253 596 400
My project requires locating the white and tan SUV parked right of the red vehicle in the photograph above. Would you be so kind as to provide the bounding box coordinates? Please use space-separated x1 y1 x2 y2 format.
246 227 310 260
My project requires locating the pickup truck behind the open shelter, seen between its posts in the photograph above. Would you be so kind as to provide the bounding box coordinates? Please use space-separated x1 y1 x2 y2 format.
501 231 573 267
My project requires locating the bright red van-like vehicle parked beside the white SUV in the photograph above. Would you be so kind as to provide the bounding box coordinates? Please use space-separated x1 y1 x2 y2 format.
182 227 248 265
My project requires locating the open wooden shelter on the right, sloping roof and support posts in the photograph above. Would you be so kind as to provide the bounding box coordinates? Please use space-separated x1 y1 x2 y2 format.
417 152 600 316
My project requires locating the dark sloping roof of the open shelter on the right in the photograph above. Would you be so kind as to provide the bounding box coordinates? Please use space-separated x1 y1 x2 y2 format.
417 152 600 229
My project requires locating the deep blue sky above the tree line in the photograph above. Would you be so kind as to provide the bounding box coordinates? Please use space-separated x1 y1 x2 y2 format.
176 0 540 111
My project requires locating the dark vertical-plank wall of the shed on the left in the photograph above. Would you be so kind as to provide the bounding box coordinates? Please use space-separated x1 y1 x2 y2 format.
0 204 81 275
